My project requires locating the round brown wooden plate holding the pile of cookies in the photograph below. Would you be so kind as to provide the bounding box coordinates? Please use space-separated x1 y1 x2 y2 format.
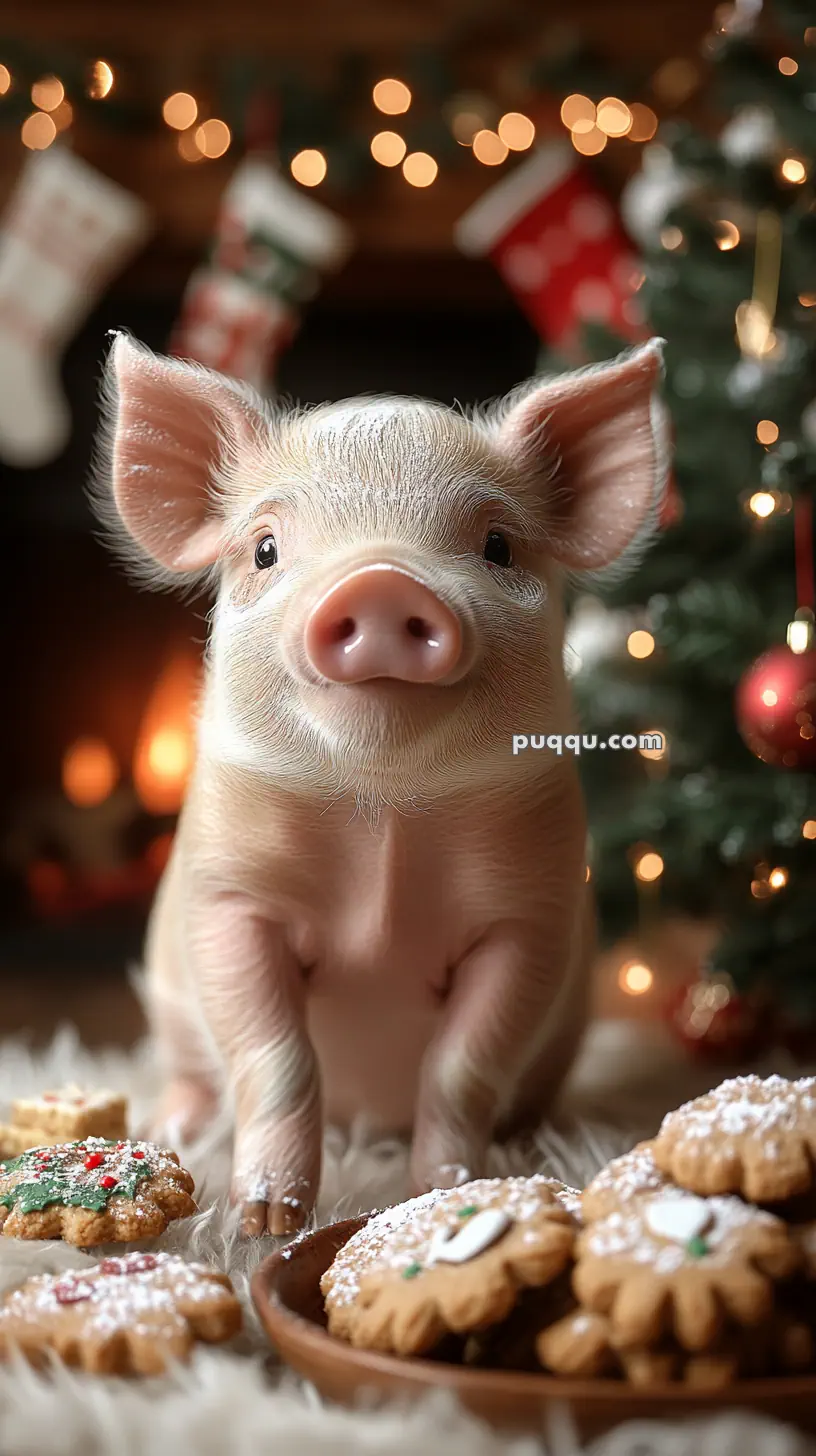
252 1217 816 1440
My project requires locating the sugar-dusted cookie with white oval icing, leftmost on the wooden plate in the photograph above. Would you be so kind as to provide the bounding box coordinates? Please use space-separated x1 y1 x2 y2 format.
321 1176 577 1354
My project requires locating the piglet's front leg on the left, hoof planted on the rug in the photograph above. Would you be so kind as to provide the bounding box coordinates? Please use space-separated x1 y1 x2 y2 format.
189 894 322 1236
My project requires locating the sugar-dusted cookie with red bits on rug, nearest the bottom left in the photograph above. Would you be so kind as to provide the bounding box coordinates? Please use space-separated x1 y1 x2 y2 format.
0 1254 240 1374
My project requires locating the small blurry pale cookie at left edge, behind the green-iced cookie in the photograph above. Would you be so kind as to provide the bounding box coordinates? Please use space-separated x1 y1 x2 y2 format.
0 1085 127 1156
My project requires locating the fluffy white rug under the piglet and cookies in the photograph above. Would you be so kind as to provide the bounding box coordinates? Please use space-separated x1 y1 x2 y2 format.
0 1024 816 1456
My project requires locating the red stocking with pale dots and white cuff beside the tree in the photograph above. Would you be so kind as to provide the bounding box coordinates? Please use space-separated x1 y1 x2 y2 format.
456 143 647 352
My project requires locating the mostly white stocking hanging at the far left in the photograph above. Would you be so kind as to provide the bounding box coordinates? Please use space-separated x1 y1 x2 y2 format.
0 146 149 466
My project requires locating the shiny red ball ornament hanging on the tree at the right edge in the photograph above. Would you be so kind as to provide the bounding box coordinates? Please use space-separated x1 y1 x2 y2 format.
736 646 816 769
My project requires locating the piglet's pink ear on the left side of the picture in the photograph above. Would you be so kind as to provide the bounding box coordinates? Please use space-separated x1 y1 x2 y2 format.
95 333 264 584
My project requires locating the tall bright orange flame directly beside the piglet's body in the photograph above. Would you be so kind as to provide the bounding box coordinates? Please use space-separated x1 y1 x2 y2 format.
133 652 200 814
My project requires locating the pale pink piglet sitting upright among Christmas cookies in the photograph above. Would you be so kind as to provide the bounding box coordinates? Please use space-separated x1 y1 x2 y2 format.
96 333 667 1235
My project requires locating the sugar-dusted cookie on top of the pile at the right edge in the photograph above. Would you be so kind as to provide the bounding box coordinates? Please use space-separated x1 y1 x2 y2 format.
653 1076 816 1203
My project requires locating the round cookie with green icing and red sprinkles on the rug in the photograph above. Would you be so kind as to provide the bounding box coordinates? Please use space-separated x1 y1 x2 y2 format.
0 1137 195 1248
